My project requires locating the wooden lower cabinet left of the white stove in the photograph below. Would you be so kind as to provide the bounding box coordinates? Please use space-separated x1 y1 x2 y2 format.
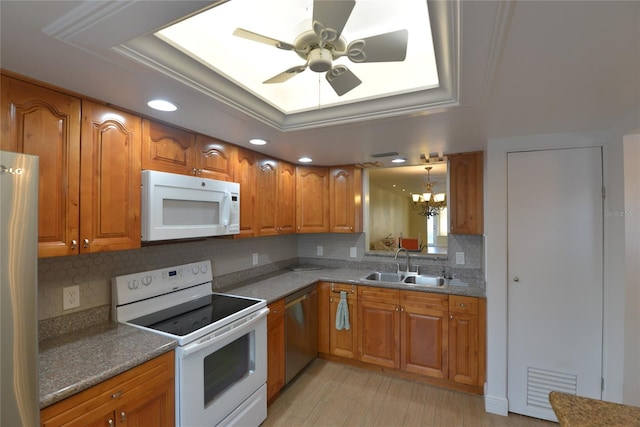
40 351 175 427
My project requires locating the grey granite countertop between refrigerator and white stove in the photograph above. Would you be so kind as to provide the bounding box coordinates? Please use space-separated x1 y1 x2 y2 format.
39 324 177 409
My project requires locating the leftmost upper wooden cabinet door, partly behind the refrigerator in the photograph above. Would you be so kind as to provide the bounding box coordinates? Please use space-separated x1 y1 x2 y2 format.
0 76 81 258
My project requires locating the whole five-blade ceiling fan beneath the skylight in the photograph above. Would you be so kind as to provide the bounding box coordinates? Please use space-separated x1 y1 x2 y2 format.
233 0 409 96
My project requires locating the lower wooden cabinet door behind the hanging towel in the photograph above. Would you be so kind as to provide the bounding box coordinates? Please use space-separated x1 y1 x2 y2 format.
329 287 358 359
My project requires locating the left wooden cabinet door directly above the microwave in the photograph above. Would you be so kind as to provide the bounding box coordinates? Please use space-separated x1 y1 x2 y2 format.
142 119 196 175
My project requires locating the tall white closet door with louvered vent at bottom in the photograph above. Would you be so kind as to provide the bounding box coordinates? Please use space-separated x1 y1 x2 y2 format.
507 147 603 421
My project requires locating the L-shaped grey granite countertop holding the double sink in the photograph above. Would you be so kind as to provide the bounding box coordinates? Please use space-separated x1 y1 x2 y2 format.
217 268 485 304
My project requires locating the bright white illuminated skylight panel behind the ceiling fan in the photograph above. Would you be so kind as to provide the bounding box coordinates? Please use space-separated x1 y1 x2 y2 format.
155 0 439 114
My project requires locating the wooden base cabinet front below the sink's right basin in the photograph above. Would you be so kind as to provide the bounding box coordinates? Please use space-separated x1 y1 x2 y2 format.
400 291 449 379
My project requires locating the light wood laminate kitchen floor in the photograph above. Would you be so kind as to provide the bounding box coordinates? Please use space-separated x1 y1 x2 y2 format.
262 360 557 427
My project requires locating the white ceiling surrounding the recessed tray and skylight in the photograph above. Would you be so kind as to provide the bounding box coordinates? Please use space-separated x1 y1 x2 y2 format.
0 0 640 165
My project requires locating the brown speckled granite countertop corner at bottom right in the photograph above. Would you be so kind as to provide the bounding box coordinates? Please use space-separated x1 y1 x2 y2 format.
549 391 640 427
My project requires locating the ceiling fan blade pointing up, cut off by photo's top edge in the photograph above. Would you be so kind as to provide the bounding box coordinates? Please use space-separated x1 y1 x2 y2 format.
312 0 356 46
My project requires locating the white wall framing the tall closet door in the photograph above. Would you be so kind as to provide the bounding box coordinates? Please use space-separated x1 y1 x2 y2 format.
485 132 624 415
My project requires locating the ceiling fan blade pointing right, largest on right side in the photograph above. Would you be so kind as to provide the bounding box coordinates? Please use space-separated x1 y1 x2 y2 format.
347 30 409 62
